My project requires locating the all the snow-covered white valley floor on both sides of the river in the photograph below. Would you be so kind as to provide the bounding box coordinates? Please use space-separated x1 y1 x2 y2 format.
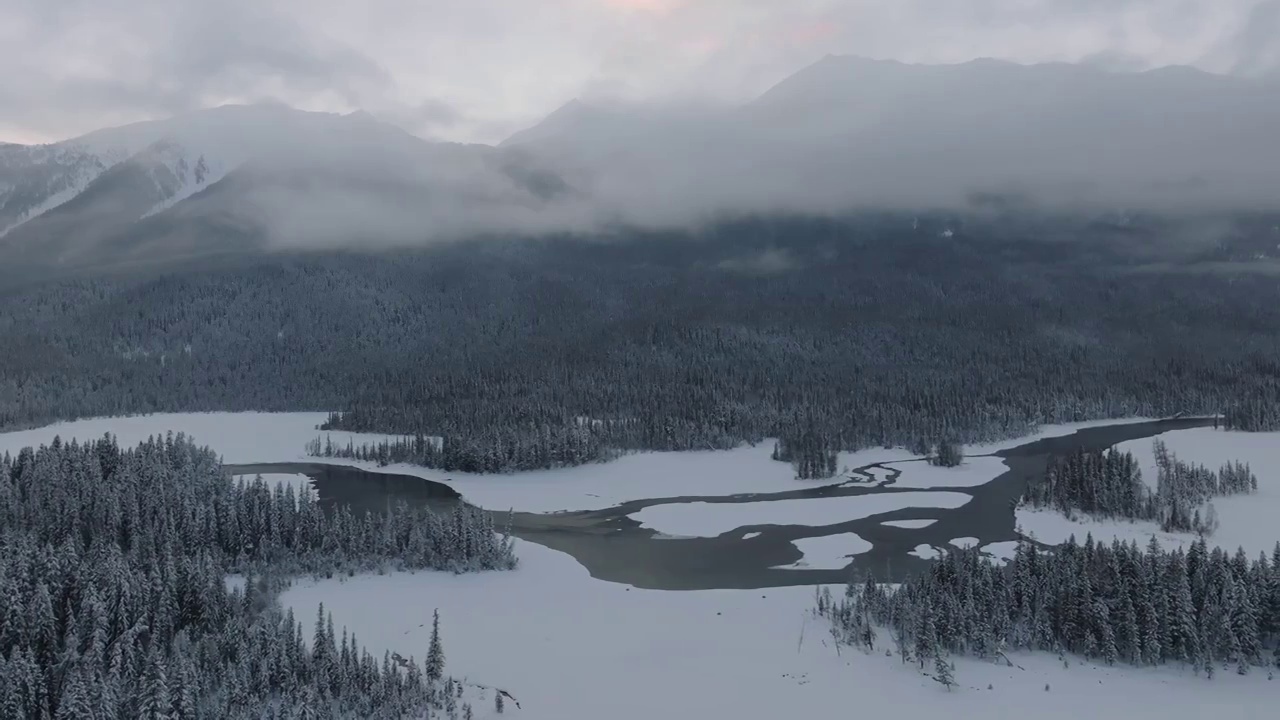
0 414 1280 720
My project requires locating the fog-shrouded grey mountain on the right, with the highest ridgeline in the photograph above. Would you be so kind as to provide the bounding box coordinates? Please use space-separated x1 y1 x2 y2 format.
508 55 1280 219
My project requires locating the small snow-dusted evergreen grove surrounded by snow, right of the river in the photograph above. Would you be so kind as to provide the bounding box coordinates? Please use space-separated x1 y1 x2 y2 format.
1023 439 1258 536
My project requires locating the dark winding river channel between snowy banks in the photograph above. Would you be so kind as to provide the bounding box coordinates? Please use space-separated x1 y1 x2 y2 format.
228 418 1213 591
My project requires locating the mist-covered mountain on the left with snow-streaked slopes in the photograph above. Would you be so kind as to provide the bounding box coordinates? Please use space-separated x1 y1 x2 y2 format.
0 105 568 272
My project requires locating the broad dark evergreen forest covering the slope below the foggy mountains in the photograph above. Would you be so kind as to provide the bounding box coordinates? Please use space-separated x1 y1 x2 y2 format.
0 214 1280 473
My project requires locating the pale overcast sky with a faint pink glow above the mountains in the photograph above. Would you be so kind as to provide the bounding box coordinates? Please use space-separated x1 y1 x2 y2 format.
0 0 1280 142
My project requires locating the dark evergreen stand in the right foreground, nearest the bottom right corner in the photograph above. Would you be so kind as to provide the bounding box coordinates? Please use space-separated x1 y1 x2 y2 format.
817 537 1280 685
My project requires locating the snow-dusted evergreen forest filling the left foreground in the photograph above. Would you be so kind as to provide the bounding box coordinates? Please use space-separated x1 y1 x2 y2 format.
0 436 515 720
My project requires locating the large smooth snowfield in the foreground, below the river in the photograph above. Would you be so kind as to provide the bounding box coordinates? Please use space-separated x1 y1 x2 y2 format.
283 543 1275 720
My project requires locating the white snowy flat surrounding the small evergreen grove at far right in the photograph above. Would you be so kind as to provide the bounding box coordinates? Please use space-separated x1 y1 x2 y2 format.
1018 428 1280 557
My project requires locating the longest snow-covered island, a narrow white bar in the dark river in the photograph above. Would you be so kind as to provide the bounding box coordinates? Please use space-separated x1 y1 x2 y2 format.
631 492 973 538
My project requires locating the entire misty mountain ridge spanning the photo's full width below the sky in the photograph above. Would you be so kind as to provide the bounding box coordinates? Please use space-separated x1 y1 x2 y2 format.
0 55 1280 278
